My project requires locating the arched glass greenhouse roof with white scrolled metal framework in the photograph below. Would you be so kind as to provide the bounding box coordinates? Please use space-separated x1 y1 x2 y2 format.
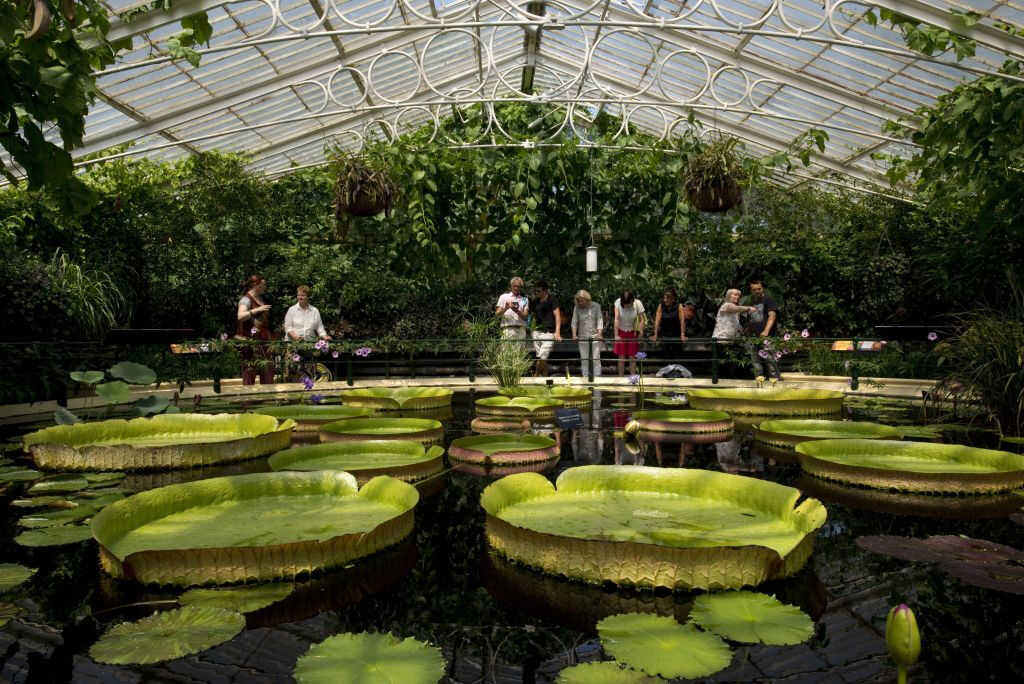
18 0 1024 191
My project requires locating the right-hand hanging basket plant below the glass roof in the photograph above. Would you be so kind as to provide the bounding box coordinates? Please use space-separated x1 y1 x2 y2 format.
683 137 743 211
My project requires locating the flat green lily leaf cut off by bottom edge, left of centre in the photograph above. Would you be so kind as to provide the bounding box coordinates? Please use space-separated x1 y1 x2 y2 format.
294 632 444 684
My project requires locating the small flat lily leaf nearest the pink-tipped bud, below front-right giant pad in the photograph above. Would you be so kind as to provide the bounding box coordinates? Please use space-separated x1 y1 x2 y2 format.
690 592 814 646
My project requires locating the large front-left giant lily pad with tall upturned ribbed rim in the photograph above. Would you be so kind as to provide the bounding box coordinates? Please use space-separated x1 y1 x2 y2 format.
92 471 419 585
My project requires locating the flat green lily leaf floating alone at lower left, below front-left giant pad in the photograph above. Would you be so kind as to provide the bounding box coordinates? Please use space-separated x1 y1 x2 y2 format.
89 606 246 665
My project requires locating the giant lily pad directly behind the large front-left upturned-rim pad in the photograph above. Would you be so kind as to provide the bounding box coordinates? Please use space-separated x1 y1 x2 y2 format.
268 439 444 484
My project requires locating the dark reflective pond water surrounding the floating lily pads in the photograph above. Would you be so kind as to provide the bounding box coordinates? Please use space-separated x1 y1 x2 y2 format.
0 392 1024 682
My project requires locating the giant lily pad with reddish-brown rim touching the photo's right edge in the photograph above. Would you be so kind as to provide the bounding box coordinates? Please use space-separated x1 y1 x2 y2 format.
797 439 1024 494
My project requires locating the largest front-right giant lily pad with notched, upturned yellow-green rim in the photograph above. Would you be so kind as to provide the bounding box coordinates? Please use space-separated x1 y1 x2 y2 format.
480 466 825 589
